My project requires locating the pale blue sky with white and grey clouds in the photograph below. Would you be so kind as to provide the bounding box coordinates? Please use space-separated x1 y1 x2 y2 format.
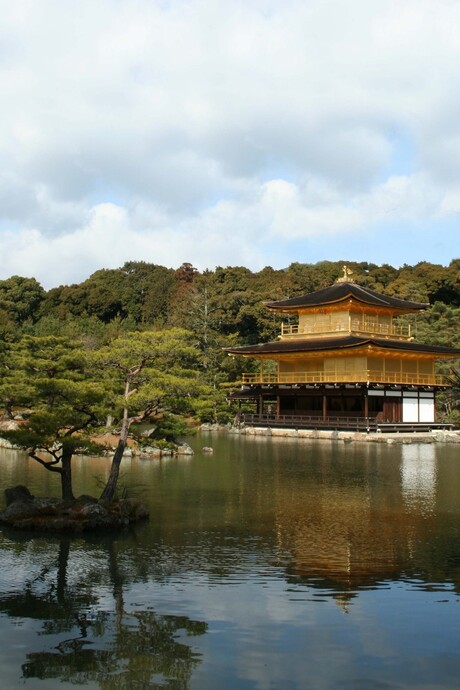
0 0 460 289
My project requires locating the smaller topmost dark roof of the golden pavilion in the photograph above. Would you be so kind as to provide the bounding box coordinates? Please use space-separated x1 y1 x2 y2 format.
266 283 429 311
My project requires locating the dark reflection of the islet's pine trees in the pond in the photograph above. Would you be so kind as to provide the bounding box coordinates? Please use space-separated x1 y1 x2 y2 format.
0 539 207 690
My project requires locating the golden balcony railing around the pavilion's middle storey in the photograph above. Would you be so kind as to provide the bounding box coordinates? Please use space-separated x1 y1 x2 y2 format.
242 369 448 386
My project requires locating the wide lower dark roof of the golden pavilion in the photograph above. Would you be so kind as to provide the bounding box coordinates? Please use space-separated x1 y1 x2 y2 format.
225 335 460 357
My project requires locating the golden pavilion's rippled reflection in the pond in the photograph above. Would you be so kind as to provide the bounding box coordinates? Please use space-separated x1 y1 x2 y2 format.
275 444 446 606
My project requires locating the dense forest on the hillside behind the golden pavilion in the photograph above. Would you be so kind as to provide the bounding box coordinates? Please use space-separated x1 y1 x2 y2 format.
0 259 460 428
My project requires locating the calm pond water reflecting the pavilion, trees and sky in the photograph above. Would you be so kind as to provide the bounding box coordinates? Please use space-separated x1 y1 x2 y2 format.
0 434 460 690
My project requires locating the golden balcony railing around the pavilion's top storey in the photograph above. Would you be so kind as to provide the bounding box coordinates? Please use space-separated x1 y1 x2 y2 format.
281 319 412 340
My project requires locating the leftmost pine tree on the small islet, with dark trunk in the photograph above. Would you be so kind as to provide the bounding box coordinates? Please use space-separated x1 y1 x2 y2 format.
1 336 106 500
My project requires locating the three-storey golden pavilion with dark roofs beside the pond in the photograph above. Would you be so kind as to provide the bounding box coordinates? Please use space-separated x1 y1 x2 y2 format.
226 267 460 430
